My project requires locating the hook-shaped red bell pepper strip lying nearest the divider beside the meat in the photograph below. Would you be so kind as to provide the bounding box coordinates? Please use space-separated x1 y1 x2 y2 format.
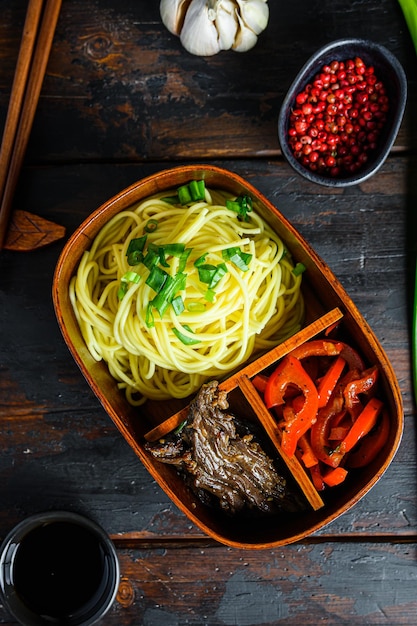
264 354 318 457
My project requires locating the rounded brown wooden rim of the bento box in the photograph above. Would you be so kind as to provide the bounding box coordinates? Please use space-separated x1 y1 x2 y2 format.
52 164 403 549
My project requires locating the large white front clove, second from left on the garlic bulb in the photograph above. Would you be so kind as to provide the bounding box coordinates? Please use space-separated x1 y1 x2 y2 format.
180 0 221 56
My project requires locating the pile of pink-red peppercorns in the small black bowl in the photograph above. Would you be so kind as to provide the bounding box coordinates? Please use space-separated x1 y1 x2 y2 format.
288 58 389 177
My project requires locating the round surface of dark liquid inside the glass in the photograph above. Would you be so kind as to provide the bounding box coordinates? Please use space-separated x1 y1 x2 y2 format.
13 522 104 618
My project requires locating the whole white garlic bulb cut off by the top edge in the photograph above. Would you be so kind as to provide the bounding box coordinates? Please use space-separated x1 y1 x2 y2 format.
160 0 269 56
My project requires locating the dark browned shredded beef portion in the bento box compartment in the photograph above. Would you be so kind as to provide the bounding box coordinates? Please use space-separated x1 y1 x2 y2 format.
146 381 294 513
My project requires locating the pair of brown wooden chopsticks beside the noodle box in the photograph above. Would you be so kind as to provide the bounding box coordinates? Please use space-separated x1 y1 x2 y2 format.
0 0 62 250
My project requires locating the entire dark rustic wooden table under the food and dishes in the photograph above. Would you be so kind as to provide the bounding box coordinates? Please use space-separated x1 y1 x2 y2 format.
0 0 417 626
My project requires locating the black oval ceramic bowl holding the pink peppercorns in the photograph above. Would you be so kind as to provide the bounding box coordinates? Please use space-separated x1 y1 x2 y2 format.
278 39 407 187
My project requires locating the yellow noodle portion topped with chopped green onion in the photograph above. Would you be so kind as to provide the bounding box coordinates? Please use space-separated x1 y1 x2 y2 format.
70 184 304 405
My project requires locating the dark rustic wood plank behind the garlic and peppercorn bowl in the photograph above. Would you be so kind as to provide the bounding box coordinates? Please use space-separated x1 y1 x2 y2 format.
0 0 417 163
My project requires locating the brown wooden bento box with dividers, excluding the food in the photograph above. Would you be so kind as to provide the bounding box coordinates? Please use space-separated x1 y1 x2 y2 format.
53 165 403 549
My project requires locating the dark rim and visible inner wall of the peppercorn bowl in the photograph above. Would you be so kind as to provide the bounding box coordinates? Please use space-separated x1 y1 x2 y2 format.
278 37 407 187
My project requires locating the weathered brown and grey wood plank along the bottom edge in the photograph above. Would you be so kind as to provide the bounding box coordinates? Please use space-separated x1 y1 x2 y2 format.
0 542 406 626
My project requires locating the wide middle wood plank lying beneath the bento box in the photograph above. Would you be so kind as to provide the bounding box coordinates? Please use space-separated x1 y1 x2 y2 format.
0 157 417 539
